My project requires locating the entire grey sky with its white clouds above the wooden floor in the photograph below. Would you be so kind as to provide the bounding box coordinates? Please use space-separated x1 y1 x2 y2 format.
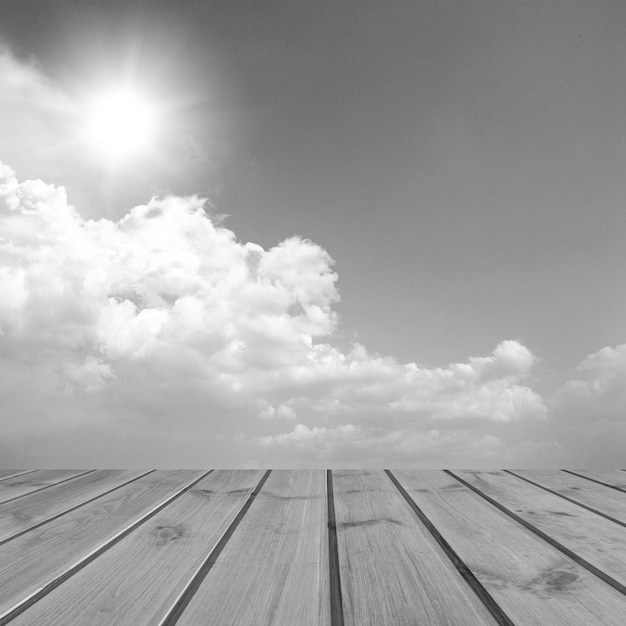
0 0 626 468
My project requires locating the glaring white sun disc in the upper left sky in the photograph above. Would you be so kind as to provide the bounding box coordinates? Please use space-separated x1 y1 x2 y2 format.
87 87 158 162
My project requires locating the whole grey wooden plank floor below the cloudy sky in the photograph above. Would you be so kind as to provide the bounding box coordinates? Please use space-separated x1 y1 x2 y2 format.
0 470 626 626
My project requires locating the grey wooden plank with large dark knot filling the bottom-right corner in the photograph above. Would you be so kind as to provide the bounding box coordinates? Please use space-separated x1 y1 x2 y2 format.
393 470 626 626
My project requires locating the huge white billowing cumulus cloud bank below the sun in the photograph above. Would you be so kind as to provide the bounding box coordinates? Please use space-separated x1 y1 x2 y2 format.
0 161 546 466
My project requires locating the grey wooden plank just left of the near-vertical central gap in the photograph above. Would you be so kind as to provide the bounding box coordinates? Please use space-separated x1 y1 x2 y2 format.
177 470 330 626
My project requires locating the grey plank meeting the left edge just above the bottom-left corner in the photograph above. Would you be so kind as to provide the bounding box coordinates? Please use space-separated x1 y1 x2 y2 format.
0 470 205 624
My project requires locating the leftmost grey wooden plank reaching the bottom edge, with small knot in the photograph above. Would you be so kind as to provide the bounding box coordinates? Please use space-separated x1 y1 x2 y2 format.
11 470 266 626
